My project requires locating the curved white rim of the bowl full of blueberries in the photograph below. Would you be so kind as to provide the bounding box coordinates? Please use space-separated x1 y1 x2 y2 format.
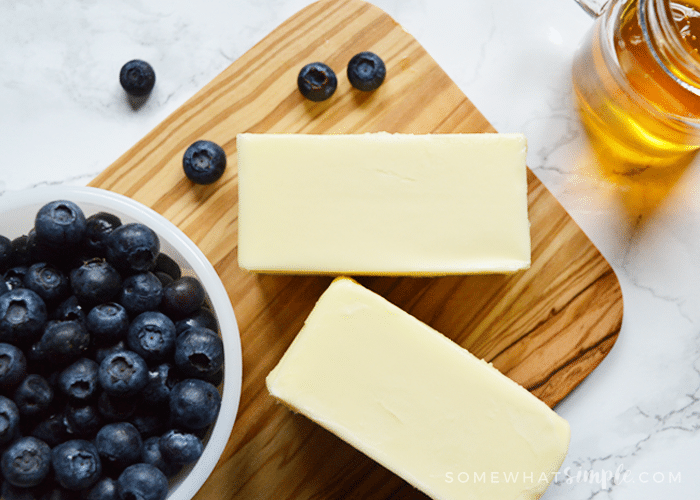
0 185 243 500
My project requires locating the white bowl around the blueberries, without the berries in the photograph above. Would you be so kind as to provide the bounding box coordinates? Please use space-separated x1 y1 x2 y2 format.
0 186 242 500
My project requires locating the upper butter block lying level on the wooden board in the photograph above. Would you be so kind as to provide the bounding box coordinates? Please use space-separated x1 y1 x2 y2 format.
237 133 530 276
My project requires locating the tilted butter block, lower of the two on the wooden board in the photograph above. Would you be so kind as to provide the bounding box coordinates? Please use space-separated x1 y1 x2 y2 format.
266 278 570 500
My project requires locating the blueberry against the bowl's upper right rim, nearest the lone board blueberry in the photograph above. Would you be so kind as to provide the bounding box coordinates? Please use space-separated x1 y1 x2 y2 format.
107 222 160 274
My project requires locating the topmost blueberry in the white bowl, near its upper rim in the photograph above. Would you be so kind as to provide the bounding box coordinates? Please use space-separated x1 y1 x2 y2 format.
34 200 86 251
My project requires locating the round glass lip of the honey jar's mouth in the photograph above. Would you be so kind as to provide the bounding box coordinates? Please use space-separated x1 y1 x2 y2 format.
637 0 700 96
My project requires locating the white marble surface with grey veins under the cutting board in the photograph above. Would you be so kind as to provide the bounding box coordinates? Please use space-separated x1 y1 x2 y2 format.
0 0 700 500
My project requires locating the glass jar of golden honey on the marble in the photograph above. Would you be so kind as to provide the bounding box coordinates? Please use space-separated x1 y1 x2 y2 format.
573 0 700 171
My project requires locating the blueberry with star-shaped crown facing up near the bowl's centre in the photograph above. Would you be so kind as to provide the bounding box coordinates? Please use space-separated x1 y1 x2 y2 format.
97 350 148 396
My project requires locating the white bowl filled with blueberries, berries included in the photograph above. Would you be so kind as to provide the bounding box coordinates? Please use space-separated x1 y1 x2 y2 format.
0 186 242 500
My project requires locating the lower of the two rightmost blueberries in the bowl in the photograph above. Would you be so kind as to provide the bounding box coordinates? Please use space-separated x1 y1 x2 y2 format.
170 379 221 431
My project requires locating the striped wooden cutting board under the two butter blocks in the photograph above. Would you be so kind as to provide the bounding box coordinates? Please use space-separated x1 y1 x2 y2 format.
91 0 622 500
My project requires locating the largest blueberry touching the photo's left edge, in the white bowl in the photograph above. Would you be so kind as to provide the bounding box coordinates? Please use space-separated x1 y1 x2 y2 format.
0 288 47 344
